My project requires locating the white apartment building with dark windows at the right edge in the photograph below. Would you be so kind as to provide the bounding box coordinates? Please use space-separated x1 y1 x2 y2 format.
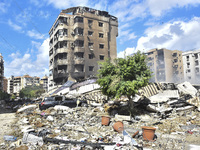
183 50 200 84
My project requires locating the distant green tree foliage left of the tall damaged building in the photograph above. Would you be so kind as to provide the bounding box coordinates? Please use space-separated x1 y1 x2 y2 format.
19 86 45 98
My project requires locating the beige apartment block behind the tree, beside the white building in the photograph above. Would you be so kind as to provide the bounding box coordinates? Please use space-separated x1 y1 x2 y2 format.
146 48 183 83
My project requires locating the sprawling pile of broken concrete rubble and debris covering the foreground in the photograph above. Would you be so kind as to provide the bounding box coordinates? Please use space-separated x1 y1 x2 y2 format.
0 83 200 150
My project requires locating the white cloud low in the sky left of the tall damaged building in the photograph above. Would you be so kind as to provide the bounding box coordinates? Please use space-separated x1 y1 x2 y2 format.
5 39 49 77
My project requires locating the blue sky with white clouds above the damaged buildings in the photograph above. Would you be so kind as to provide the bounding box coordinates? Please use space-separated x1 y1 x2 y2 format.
0 0 200 77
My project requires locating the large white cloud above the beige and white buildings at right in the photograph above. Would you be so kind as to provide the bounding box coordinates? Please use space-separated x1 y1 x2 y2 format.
136 17 200 50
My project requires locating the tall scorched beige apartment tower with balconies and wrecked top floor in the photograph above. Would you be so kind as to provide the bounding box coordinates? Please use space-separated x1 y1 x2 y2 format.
49 7 118 88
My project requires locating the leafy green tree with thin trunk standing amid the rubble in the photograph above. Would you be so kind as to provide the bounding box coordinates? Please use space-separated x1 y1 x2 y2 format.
97 51 151 115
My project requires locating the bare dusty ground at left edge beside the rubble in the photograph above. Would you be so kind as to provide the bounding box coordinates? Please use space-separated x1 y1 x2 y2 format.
0 107 16 143
